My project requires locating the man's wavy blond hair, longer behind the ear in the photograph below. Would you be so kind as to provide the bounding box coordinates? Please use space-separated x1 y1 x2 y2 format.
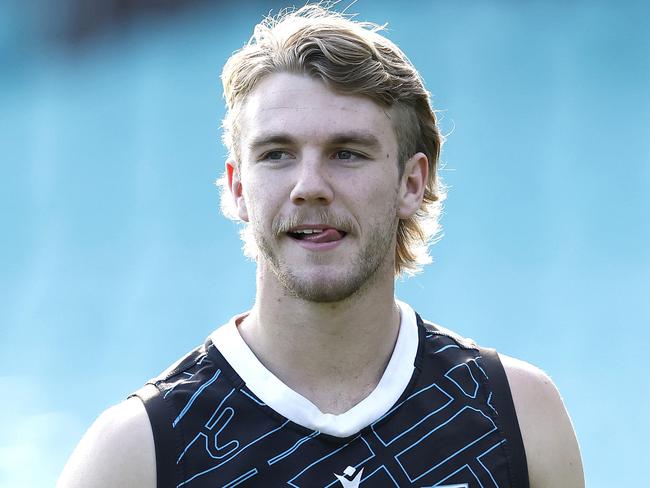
221 4 445 275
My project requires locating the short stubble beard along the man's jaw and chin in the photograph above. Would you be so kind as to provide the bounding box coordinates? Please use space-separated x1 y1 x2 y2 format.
253 215 397 303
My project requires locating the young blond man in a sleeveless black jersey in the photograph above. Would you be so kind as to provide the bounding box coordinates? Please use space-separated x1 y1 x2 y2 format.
59 6 584 488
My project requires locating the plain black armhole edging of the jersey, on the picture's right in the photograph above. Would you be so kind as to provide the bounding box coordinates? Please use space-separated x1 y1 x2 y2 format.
479 346 529 488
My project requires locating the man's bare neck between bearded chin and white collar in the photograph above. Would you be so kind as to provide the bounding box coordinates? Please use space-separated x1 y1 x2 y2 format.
239 262 400 414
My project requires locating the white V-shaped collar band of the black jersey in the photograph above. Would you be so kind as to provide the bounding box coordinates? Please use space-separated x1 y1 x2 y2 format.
210 300 418 437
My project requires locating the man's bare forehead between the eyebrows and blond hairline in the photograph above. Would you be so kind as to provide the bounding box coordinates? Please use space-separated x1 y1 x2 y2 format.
240 73 397 151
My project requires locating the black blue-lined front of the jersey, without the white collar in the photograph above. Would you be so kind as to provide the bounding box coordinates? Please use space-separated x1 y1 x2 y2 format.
139 318 512 488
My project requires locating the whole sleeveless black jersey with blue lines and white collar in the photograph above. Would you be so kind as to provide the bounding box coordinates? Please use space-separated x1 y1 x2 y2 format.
137 302 528 488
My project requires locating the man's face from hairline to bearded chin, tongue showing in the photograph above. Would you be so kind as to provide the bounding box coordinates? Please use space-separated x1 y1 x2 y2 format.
231 73 399 302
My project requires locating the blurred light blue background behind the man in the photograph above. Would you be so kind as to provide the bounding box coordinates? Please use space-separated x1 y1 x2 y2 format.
0 0 650 488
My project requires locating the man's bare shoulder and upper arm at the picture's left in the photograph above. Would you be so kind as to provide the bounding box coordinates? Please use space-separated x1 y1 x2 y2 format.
56 398 156 488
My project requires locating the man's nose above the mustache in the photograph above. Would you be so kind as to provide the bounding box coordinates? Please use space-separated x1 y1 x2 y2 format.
291 156 334 205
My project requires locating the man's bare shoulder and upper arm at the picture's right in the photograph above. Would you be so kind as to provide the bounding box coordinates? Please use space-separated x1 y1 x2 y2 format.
499 354 584 488
